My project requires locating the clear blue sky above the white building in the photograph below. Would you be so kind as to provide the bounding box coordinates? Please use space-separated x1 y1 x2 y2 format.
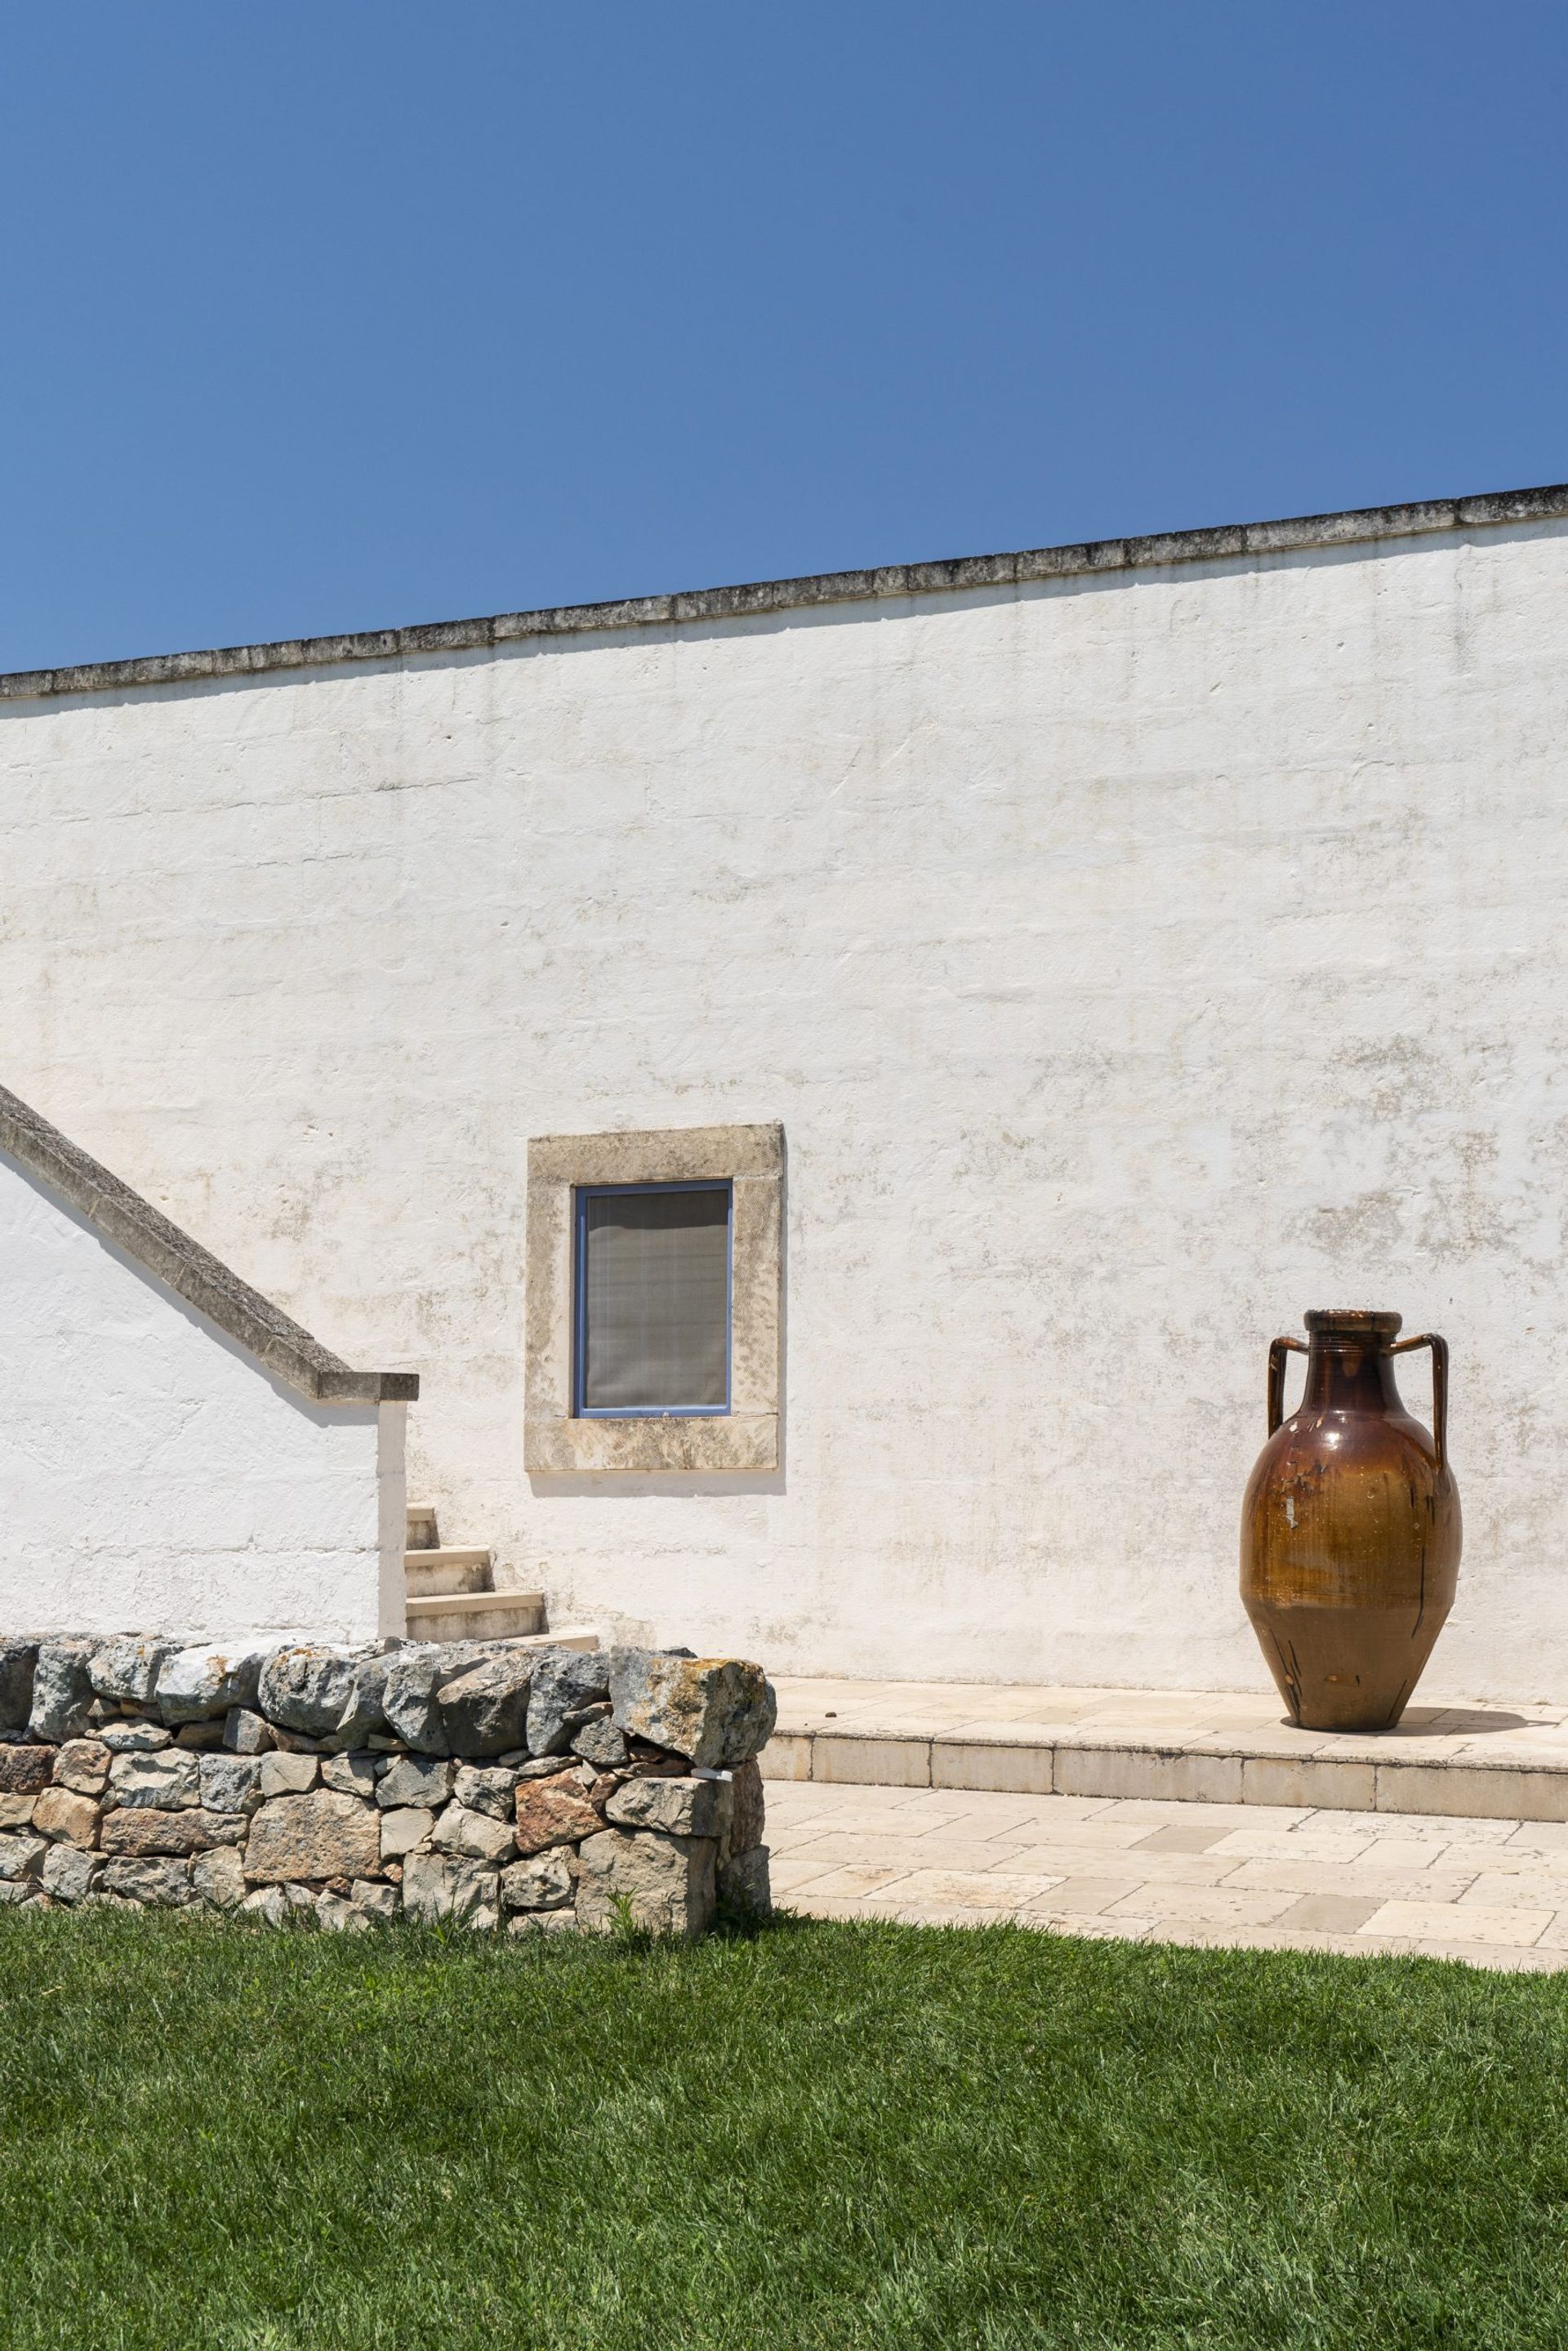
0 0 1568 670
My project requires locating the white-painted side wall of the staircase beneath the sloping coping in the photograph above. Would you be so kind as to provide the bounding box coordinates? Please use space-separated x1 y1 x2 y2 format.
0 1152 407 1639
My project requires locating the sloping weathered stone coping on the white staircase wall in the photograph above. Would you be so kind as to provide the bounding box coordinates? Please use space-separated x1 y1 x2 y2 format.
0 1086 418 1404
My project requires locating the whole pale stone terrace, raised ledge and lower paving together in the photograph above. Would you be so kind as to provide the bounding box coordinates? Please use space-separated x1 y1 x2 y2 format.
764 1681 1568 1970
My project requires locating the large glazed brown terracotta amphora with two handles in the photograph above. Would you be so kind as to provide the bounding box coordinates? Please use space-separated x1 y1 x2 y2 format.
1241 1310 1460 1730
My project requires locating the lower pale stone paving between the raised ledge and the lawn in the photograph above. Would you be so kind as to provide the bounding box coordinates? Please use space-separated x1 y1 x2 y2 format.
768 1779 1568 1970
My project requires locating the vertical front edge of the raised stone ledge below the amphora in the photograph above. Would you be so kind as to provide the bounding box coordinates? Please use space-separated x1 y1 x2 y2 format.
762 1723 1568 1822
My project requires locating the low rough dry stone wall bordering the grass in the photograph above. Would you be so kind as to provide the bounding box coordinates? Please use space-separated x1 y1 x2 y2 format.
0 1636 776 1937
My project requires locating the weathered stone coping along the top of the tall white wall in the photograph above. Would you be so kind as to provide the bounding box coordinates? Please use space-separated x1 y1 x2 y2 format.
0 482 1568 701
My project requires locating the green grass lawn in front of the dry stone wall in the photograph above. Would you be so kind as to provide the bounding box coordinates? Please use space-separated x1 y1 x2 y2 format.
0 1914 1568 2351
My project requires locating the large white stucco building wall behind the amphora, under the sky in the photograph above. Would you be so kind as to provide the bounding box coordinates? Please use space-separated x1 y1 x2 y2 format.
0 524 1568 1698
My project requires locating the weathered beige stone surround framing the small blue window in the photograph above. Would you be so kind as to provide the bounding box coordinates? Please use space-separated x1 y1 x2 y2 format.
522 1126 783 1476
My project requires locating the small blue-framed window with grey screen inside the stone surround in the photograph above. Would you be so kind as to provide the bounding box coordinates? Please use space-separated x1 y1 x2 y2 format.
571 1182 733 1420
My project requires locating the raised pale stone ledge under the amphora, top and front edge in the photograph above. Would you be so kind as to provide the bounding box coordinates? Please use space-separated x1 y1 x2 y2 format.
762 1679 1568 1829
